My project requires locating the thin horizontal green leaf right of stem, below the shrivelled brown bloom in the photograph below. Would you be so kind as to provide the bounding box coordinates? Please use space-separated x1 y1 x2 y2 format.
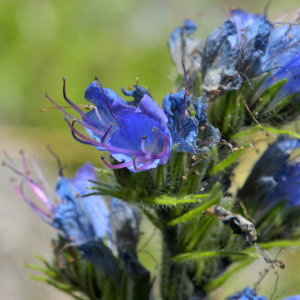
172 251 260 262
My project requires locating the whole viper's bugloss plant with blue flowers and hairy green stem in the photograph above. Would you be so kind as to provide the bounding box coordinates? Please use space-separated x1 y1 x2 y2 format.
4 5 300 300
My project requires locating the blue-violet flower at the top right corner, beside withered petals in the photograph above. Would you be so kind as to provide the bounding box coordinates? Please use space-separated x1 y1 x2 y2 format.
228 9 300 99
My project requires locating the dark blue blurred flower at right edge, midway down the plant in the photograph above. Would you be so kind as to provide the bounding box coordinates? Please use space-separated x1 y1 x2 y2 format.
238 136 300 208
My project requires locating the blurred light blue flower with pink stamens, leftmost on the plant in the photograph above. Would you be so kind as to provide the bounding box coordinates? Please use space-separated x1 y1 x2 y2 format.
5 153 111 244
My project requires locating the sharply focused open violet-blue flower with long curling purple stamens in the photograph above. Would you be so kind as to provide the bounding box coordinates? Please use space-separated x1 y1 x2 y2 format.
46 80 172 171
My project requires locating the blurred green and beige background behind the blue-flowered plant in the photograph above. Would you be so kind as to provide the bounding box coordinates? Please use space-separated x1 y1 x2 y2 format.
0 0 300 300
